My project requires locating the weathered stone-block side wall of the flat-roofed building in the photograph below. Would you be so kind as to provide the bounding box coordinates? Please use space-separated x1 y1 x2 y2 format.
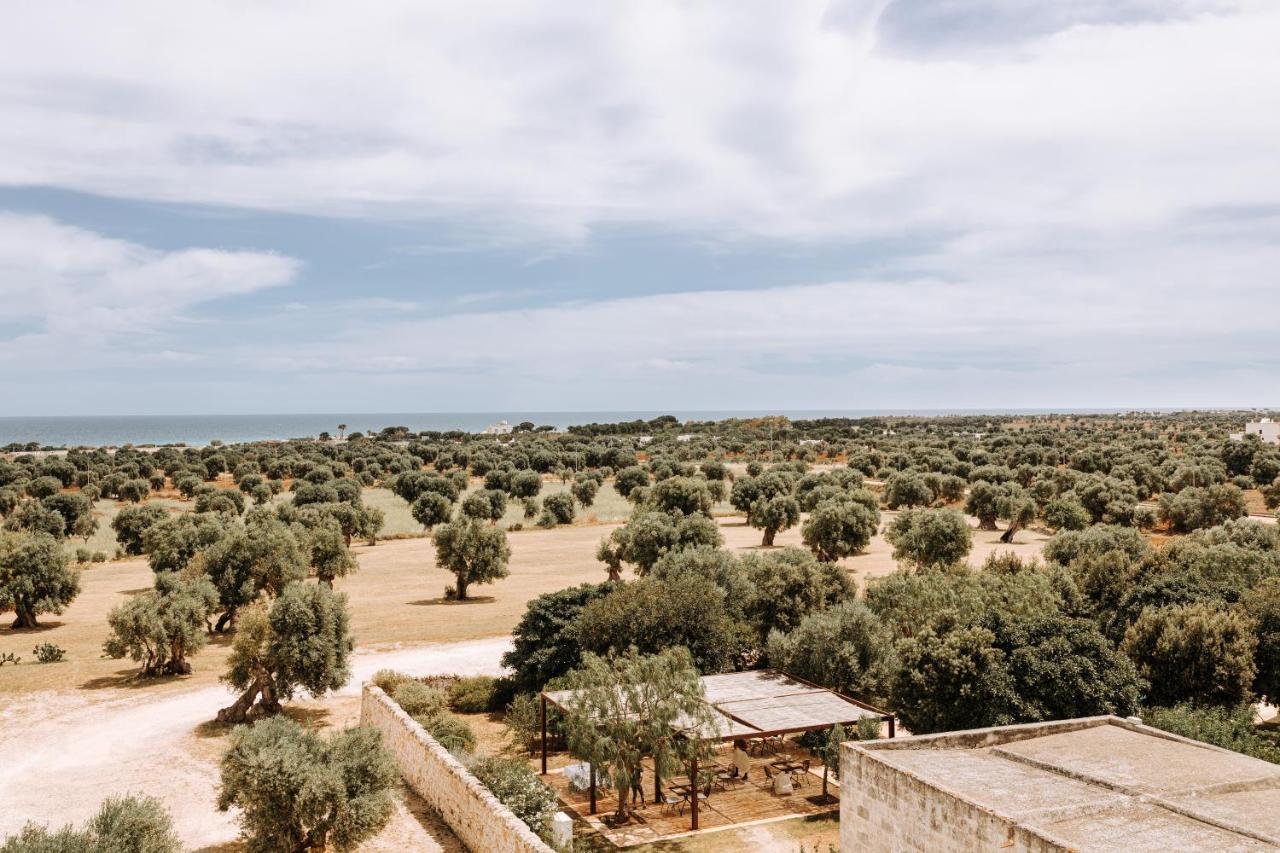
840 743 1069 853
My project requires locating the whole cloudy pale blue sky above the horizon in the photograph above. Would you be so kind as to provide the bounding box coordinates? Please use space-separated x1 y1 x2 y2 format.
0 0 1280 415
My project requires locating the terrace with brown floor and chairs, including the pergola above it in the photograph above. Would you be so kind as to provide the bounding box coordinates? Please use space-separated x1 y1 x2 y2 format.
541 670 896 847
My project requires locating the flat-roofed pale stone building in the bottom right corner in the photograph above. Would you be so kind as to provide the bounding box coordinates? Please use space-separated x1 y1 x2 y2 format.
840 717 1280 853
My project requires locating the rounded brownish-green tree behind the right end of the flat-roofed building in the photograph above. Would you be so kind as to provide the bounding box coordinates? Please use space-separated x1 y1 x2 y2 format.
1120 603 1258 706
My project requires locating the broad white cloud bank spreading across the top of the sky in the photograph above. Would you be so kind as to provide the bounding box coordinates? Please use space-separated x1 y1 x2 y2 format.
0 0 1280 238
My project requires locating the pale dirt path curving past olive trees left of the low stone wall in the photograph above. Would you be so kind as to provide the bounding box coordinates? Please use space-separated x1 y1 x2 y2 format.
0 638 509 849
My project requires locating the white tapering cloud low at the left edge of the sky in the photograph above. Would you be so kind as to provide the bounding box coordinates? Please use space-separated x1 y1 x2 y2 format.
0 213 298 364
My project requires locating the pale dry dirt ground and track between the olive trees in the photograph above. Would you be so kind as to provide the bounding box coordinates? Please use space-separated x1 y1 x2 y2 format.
0 514 1047 853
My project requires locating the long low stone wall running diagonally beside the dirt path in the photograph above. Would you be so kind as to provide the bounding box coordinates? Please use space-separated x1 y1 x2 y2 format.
360 684 554 853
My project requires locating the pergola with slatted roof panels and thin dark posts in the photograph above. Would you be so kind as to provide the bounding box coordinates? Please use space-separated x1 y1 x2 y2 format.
540 670 897 830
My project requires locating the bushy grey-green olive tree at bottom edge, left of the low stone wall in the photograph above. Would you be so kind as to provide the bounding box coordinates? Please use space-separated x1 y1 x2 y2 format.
218 717 397 853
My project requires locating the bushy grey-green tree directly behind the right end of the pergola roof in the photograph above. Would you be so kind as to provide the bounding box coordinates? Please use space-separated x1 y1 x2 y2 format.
768 601 893 699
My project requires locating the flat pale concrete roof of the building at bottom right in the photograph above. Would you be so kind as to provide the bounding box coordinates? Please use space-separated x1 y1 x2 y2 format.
854 717 1280 853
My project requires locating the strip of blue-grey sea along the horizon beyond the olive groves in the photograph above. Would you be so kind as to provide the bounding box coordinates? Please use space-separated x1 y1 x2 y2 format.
0 409 1141 447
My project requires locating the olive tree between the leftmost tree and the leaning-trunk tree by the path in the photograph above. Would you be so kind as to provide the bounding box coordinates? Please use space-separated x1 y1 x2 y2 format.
102 573 218 676
